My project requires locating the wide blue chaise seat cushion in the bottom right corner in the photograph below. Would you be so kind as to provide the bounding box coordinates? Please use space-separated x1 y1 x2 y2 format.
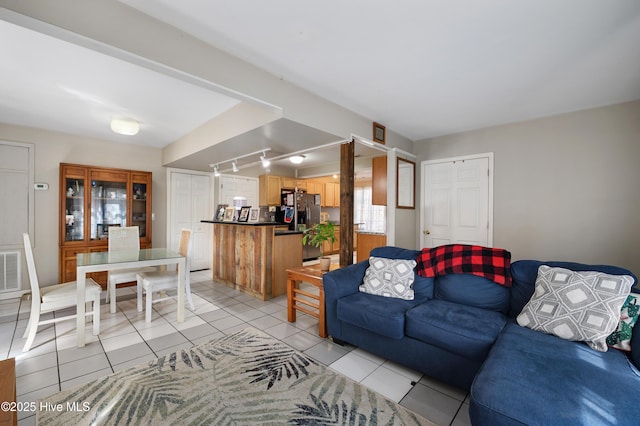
469 320 640 425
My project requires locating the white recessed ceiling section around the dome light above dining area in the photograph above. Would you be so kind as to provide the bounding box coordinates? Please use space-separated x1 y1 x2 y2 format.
0 20 240 148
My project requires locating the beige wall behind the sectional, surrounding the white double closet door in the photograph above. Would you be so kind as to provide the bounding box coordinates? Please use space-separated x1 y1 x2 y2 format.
415 101 640 274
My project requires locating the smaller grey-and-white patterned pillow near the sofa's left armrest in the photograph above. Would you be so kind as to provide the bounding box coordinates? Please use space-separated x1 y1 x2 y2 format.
359 256 416 300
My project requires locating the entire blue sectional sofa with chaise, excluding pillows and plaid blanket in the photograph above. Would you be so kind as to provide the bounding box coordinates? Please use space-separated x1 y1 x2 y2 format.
323 247 640 425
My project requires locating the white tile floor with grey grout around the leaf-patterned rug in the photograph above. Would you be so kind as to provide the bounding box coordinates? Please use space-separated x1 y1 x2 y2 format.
0 271 471 426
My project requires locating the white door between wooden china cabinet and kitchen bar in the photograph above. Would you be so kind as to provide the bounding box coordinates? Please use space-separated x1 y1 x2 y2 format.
169 171 212 270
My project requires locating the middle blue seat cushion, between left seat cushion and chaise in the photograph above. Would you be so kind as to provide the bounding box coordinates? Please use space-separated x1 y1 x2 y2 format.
406 298 507 361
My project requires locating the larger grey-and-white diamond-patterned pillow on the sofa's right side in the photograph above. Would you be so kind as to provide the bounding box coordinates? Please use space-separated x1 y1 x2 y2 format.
517 265 633 352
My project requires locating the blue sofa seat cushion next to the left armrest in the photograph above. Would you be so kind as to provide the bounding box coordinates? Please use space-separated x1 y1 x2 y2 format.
337 293 428 339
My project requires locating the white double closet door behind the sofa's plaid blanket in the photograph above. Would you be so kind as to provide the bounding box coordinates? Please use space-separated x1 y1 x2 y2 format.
421 154 493 247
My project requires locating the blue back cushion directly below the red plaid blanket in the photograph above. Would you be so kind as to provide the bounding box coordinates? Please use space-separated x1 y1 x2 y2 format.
434 274 509 314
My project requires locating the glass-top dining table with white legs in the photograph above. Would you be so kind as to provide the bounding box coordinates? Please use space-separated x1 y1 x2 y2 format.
76 248 186 348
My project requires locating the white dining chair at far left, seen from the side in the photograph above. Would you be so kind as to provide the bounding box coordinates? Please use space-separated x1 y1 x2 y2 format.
22 233 102 352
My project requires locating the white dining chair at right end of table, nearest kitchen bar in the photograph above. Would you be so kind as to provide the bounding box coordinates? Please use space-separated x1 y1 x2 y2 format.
138 229 195 322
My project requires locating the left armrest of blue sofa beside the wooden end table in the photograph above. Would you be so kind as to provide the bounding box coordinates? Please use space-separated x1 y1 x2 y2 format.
322 260 369 339
